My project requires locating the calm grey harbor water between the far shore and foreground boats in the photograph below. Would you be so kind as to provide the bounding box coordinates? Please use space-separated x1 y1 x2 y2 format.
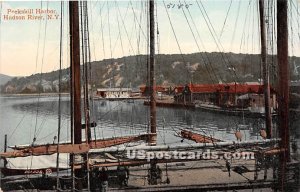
0 96 300 150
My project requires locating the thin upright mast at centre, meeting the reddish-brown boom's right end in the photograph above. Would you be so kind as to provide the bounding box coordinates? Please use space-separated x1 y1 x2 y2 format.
149 0 156 145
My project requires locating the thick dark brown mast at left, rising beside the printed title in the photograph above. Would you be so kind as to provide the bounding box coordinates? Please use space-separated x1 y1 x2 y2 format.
69 1 82 144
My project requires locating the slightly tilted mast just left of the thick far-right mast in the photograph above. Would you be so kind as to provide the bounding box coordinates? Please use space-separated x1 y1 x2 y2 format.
259 0 272 139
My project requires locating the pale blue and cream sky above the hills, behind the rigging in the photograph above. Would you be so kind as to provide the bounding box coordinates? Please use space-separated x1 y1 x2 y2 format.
0 0 300 76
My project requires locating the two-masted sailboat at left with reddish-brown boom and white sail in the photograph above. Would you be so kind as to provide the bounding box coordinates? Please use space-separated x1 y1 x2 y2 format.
0 1 156 189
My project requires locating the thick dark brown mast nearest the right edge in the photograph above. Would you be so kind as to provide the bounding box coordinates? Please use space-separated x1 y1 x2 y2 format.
277 0 290 191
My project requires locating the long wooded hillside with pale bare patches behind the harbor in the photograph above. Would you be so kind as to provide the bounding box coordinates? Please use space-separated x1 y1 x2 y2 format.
1 52 300 93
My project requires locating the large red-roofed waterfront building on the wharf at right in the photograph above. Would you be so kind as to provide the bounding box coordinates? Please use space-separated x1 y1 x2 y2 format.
174 83 276 109
